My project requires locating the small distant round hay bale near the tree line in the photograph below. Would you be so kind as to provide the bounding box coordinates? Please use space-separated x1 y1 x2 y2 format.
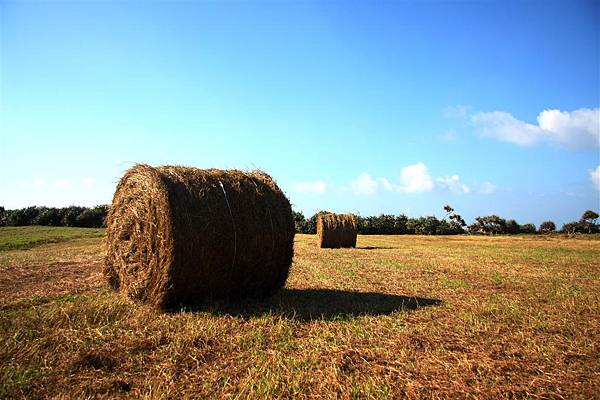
317 213 358 248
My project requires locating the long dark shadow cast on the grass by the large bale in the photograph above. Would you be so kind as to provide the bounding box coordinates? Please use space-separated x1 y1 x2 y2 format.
178 288 442 321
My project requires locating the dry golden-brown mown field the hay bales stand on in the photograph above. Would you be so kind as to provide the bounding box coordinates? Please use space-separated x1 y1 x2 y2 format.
0 228 600 399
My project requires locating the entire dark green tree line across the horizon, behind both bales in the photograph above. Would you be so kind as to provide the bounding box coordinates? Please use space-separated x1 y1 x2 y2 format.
0 205 600 235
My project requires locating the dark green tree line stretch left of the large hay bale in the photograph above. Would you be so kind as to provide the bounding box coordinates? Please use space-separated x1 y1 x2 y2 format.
0 205 108 228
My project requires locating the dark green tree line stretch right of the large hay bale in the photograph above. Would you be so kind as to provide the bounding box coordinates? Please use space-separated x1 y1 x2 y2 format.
293 205 600 235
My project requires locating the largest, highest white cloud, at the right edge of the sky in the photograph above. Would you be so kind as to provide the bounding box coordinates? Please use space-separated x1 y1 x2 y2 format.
471 108 600 149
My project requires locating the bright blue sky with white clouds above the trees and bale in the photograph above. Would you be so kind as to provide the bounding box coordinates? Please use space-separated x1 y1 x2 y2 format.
0 1 600 224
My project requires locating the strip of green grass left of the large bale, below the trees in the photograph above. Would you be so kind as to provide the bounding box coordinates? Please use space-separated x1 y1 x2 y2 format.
0 226 104 251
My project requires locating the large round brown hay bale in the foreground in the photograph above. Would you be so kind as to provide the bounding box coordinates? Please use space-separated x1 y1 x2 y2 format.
105 164 294 308
